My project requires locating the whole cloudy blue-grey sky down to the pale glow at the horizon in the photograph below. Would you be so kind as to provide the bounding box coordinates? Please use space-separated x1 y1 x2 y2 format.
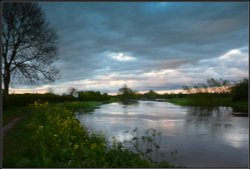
10 2 249 94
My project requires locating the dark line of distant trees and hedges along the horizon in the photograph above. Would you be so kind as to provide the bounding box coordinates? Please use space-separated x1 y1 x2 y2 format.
4 79 248 106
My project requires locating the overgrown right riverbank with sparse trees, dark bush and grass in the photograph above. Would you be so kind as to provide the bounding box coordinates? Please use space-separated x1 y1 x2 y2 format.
174 79 248 112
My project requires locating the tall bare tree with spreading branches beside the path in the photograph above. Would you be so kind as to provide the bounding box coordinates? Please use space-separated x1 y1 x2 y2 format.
2 3 59 104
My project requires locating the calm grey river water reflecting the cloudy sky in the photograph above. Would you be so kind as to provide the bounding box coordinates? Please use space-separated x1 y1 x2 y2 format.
77 101 249 168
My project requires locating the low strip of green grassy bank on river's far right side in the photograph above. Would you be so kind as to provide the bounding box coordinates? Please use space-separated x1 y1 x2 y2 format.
167 97 248 113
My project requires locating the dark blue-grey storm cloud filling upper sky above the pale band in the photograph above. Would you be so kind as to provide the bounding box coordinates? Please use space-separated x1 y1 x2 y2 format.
12 2 248 93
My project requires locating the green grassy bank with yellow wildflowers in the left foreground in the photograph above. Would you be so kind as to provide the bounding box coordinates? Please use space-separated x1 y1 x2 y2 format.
3 102 174 168
